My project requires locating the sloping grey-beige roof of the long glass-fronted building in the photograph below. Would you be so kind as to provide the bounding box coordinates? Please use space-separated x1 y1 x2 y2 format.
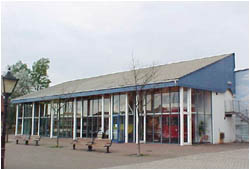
14 54 232 101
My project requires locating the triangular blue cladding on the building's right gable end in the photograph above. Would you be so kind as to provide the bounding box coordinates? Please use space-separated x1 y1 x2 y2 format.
178 54 235 93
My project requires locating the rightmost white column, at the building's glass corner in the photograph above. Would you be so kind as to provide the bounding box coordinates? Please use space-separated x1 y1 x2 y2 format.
187 88 192 145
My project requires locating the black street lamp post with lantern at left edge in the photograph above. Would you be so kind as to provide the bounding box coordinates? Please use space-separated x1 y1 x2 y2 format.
1 69 18 169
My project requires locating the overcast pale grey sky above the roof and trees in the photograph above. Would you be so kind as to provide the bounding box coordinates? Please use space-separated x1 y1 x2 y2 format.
1 2 249 85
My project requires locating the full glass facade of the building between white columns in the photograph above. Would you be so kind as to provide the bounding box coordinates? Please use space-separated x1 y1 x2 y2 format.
17 87 212 144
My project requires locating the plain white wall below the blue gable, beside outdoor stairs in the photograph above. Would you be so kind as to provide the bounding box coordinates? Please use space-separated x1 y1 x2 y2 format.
212 90 236 144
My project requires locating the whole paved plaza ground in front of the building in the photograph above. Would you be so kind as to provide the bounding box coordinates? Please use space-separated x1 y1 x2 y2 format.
6 136 249 169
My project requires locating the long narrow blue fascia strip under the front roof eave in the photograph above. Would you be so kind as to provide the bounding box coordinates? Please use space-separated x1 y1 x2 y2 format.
11 81 177 104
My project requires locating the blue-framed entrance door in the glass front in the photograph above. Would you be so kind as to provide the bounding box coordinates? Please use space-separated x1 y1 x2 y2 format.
112 115 125 143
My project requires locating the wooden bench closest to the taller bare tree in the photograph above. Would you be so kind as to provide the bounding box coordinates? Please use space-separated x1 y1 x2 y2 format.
87 132 112 153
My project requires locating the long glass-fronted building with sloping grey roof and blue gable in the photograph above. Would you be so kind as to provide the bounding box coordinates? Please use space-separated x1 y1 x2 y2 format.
12 53 238 145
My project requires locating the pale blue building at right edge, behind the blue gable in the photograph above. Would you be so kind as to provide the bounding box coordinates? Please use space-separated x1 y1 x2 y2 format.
235 69 249 142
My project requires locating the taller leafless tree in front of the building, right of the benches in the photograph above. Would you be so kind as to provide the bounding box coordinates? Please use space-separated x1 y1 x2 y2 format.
129 56 158 156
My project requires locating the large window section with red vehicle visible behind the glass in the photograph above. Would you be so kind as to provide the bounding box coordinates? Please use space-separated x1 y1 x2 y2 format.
146 87 179 143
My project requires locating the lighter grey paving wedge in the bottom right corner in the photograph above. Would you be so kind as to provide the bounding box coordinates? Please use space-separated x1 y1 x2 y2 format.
111 149 249 169
